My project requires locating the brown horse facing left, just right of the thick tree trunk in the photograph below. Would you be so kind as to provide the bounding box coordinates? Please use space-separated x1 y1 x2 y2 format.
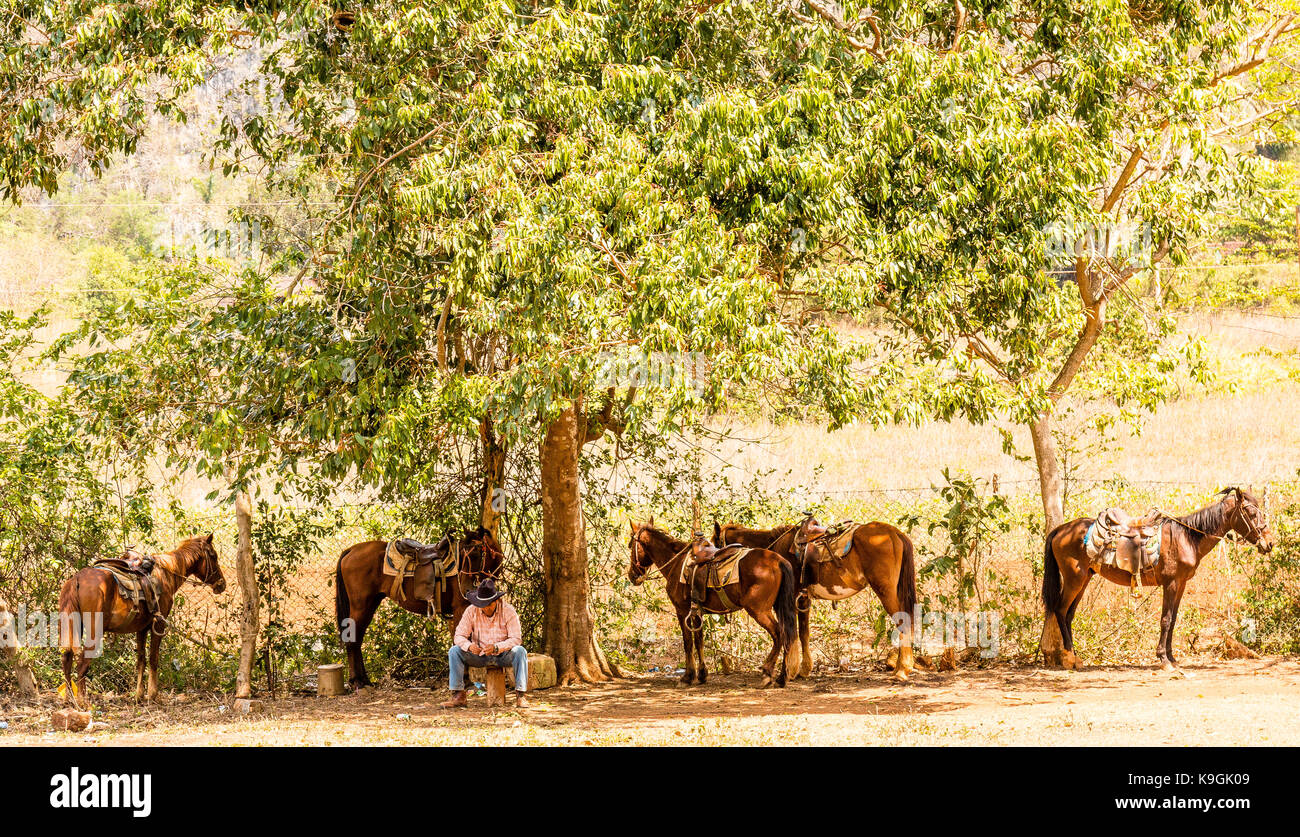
628 517 800 689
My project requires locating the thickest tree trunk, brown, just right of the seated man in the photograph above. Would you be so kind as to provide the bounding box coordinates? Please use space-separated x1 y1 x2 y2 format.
540 407 618 685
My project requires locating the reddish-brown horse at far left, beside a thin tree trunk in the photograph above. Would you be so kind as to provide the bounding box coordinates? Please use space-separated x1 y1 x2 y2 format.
59 534 226 707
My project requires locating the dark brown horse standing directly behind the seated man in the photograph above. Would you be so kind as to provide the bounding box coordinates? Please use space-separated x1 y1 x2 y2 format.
334 526 506 689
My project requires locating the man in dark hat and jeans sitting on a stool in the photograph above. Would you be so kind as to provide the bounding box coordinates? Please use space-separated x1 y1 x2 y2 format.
442 578 528 710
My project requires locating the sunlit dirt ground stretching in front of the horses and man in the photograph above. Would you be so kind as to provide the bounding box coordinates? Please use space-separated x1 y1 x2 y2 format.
0 658 1300 746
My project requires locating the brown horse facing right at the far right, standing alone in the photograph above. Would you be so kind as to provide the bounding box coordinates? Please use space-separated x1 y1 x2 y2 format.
1043 487 1273 672
